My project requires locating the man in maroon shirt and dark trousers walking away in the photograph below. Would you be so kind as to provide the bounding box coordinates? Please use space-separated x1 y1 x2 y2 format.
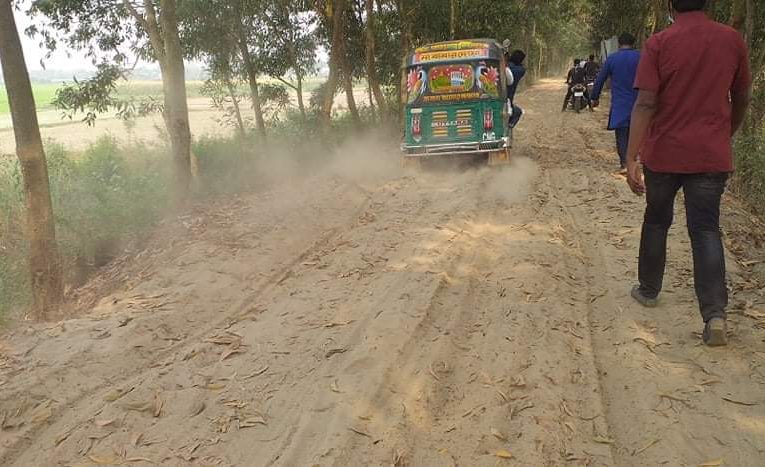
627 0 752 346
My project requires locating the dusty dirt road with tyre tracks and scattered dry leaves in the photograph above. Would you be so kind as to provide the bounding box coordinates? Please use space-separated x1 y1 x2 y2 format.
0 83 765 467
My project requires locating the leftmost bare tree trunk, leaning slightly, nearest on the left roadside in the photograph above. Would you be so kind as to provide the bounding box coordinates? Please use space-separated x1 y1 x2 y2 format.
0 0 63 319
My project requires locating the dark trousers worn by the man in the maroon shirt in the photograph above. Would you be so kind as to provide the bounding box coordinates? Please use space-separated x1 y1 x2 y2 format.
638 168 728 322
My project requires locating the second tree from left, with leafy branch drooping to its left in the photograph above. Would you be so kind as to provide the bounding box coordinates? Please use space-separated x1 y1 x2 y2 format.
31 0 191 199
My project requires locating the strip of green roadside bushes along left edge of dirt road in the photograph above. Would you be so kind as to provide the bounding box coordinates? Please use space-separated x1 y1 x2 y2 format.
0 106 390 318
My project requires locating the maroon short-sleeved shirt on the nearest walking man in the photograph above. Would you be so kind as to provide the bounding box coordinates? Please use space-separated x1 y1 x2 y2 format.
635 12 752 173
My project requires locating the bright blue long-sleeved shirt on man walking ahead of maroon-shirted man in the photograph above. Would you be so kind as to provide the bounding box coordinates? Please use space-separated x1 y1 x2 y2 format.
592 49 640 130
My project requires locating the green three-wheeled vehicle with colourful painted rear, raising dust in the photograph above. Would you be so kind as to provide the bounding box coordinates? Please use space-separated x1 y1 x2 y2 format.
401 39 509 164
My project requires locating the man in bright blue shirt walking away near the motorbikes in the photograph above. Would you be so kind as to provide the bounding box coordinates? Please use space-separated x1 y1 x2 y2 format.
592 33 640 171
